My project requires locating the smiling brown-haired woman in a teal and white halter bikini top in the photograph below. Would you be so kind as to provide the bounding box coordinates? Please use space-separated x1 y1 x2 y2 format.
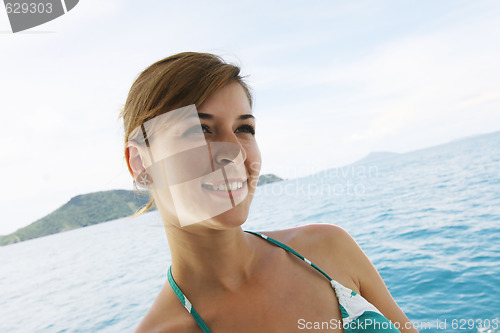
121 52 416 332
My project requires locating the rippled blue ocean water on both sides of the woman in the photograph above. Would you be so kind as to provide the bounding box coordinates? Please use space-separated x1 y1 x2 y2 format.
0 132 500 332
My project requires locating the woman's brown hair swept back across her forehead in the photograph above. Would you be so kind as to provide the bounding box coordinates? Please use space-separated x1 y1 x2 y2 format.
120 52 252 215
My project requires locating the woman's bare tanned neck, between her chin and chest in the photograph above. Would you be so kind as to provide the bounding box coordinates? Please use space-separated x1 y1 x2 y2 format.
166 226 256 290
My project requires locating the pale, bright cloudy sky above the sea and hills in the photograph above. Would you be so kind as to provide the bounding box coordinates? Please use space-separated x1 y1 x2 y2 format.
0 0 500 234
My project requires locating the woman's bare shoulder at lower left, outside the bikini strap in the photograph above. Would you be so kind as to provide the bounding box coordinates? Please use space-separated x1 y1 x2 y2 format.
134 282 199 333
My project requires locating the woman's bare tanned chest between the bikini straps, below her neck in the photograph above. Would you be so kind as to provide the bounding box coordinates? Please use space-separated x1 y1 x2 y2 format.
204 253 342 333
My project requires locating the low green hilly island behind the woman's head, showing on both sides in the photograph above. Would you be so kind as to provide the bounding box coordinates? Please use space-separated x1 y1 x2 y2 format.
0 174 282 246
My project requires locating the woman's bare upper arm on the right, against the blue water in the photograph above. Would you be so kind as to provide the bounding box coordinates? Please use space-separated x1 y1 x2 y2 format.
333 227 418 332
